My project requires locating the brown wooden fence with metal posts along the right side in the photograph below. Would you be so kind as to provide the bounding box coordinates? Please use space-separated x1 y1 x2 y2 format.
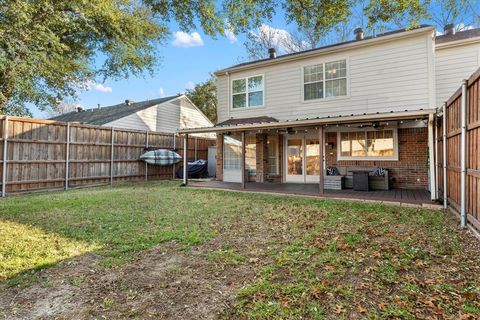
437 69 480 231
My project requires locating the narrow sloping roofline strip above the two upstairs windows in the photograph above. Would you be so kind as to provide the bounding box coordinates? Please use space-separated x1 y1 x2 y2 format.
215 24 434 75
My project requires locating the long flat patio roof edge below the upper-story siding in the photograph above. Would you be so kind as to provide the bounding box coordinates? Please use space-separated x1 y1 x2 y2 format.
178 109 436 134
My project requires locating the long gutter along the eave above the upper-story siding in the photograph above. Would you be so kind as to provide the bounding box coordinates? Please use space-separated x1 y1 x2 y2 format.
214 27 435 76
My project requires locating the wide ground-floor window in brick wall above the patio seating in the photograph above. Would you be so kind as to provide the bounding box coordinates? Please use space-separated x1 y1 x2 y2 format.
338 129 397 160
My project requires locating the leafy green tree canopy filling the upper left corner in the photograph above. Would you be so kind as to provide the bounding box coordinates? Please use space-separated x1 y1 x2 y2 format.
0 0 168 115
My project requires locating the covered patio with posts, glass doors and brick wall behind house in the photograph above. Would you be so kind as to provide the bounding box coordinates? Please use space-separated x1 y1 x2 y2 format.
179 110 437 206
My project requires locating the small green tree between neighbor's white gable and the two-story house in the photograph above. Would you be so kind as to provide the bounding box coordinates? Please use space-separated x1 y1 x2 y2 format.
186 75 218 123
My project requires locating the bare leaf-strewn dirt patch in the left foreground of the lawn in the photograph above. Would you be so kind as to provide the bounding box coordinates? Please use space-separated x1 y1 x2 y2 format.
0 237 267 319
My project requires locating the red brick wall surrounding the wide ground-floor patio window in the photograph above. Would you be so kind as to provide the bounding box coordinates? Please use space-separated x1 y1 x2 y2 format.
325 128 428 189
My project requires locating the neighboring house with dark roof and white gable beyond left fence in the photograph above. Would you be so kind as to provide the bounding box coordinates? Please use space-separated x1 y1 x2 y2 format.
51 95 213 133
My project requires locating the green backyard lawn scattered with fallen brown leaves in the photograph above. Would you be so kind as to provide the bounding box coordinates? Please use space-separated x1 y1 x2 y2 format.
0 182 480 319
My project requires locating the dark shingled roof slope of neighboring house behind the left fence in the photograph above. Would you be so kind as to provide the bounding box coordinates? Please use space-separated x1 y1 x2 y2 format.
51 95 180 125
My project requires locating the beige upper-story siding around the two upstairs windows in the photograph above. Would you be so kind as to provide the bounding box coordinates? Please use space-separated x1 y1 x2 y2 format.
217 32 434 121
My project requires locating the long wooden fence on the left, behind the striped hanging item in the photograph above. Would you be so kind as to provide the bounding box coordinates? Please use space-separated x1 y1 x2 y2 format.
0 116 215 196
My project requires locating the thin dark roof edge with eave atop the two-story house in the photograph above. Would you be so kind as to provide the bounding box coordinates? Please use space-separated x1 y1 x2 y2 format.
215 24 433 74
